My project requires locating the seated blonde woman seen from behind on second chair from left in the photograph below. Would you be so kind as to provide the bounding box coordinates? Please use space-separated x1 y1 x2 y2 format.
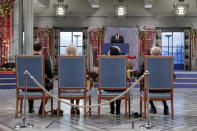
65 43 80 115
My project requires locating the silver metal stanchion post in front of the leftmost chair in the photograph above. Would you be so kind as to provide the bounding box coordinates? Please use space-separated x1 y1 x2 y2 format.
16 70 33 128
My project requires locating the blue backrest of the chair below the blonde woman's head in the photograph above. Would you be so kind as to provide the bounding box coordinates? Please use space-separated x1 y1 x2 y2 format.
58 56 87 88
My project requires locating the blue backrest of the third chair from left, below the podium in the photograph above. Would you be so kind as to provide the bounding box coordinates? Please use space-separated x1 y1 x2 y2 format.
99 56 127 89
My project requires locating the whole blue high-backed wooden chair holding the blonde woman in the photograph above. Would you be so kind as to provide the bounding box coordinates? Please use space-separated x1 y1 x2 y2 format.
57 56 91 117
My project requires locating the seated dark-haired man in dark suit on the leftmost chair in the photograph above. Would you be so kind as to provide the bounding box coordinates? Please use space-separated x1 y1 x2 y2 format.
28 41 53 114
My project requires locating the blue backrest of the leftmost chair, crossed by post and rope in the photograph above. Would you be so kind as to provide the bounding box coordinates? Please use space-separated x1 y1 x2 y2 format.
15 55 45 89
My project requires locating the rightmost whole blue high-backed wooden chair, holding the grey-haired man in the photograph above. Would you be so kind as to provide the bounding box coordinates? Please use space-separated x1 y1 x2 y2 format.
140 56 174 118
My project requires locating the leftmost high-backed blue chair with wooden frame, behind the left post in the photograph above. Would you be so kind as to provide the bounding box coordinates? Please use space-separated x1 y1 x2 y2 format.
15 55 53 117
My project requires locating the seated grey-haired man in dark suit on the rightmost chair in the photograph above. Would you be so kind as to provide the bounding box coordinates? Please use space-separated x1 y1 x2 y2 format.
137 46 169 115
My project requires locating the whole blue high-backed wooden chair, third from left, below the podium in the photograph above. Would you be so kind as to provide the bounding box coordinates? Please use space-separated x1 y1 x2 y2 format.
98 56 128 116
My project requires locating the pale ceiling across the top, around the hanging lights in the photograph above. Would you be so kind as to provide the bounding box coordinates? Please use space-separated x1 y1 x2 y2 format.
34 0 197 17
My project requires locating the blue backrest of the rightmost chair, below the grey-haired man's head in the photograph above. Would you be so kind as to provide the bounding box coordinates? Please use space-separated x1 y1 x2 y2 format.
145 56 174 89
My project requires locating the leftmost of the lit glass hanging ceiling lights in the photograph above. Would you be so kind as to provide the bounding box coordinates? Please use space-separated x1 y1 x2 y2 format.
53 0 68 17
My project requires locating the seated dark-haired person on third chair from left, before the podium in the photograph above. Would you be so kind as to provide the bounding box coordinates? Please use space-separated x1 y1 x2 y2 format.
107 46 121 115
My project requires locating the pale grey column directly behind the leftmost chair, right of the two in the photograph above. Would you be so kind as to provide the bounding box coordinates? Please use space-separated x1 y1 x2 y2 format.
23 0 33 55
